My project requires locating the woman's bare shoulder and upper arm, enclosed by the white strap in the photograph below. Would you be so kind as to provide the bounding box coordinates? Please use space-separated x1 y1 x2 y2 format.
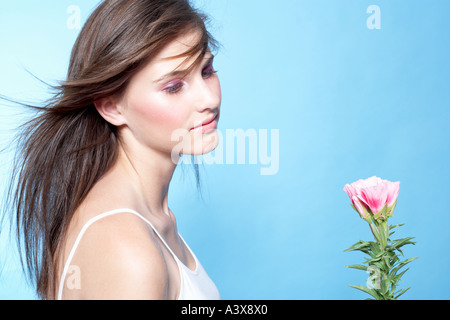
66 212 168 300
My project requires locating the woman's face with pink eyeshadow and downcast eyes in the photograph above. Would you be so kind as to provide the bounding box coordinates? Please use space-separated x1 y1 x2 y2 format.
118 32 222 161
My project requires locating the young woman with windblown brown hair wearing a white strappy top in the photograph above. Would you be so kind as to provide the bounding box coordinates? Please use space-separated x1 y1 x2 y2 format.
7 0 221 299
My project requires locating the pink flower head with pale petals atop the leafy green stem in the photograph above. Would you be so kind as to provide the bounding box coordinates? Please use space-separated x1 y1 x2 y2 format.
344 176 400 219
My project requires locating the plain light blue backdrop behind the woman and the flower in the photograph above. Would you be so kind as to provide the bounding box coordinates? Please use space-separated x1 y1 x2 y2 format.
0 0 450 299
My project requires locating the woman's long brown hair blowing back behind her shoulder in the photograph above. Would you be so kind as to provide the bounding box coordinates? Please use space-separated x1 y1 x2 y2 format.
3 0 216 299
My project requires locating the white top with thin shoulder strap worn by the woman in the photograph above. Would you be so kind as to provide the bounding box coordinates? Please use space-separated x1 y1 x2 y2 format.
58 209 220 300
